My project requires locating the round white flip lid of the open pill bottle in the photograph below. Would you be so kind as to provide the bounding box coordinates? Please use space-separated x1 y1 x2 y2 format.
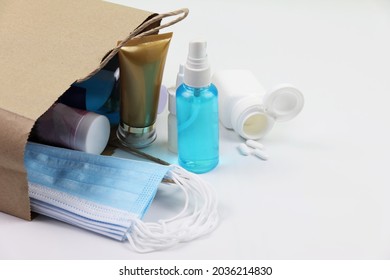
263 84 304 121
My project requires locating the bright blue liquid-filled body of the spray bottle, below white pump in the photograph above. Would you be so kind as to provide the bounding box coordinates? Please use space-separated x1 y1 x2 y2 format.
176 84 219 173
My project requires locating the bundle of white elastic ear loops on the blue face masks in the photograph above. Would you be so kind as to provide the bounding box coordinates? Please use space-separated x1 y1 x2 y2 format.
126 165 219 253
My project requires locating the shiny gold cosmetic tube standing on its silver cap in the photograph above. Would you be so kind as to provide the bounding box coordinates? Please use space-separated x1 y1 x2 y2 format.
117 33 172 148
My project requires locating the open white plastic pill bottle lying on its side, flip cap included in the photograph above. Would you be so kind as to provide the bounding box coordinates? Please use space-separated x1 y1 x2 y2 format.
213 69 304 140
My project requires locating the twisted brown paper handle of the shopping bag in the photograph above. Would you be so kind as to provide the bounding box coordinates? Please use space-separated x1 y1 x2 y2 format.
77 8 189 82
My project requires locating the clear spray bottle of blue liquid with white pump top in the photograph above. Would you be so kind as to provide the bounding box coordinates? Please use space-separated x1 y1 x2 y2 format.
176 41 219 173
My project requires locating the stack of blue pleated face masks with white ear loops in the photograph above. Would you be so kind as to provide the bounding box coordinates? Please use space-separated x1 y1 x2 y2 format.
24 143 218 252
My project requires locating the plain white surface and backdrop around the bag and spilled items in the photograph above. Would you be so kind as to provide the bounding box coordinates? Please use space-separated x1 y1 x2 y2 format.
0 0 390 259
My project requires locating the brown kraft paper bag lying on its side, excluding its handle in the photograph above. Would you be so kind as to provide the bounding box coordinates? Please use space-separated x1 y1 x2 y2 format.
0 0 152 220
